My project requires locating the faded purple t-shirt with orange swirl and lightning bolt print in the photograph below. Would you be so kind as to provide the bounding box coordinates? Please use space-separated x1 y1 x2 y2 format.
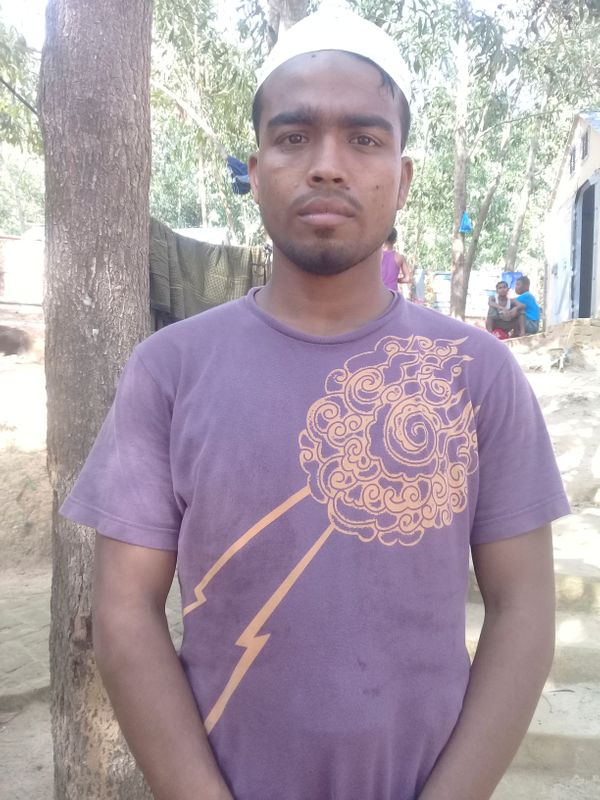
62 290 569 800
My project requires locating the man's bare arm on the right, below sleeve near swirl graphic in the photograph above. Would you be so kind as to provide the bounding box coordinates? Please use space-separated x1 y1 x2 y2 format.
419 525 554 800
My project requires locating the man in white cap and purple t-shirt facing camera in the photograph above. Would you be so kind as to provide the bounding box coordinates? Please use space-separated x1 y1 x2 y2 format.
63 7 568 800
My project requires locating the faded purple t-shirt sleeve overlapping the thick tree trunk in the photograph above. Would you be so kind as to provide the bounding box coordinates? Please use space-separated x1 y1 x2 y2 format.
60 351 181 550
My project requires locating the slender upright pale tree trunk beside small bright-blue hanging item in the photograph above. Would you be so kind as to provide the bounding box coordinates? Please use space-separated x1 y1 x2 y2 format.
450 37 469 319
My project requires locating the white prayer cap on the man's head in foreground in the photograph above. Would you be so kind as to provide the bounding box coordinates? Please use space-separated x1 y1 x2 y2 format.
256 9 411 103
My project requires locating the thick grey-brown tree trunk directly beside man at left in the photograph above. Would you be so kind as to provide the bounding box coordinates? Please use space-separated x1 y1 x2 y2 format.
40 0 152 800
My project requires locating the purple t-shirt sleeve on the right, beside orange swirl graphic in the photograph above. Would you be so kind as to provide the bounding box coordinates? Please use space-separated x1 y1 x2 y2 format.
471 352 570 544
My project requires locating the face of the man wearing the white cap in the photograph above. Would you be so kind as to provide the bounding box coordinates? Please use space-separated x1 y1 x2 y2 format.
249 51 412 275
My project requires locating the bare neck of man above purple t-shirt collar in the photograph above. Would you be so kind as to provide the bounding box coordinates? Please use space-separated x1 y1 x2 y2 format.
256 251 393 336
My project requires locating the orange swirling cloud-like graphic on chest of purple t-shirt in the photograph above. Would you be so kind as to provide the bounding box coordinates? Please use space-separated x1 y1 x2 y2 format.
299 336 477 545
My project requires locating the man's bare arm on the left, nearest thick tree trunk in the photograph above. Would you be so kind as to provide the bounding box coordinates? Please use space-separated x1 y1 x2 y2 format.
93 534 232 800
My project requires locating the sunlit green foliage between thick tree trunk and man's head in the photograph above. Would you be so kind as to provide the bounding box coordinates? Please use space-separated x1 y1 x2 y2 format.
151 0 259 243
